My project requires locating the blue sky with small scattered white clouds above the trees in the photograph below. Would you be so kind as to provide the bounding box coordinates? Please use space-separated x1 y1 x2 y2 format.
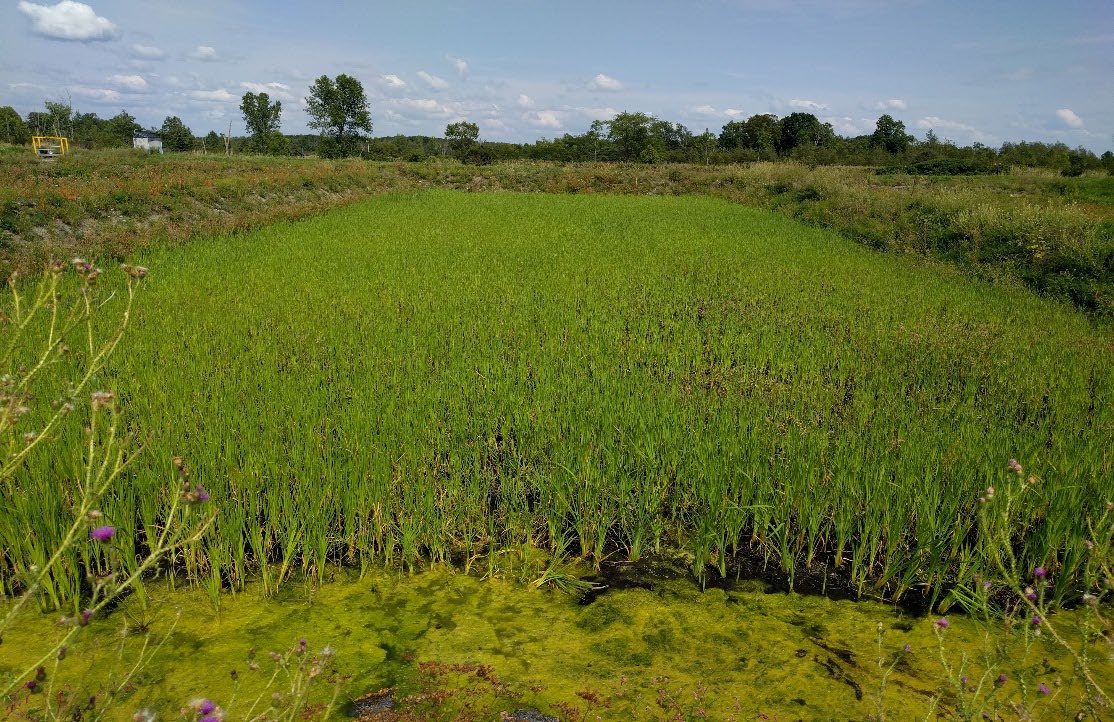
0 0 1114 152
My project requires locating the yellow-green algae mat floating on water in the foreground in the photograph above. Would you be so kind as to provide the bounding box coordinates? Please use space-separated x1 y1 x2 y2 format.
0 567 1114 720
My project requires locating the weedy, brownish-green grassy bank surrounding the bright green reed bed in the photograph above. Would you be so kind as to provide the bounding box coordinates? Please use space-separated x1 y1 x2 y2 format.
0 150 1114 315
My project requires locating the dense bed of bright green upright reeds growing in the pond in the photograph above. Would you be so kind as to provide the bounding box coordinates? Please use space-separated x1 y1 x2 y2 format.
0 190 1114 604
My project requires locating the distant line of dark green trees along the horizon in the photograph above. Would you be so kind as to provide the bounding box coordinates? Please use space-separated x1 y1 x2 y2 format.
0 96 1114 176
